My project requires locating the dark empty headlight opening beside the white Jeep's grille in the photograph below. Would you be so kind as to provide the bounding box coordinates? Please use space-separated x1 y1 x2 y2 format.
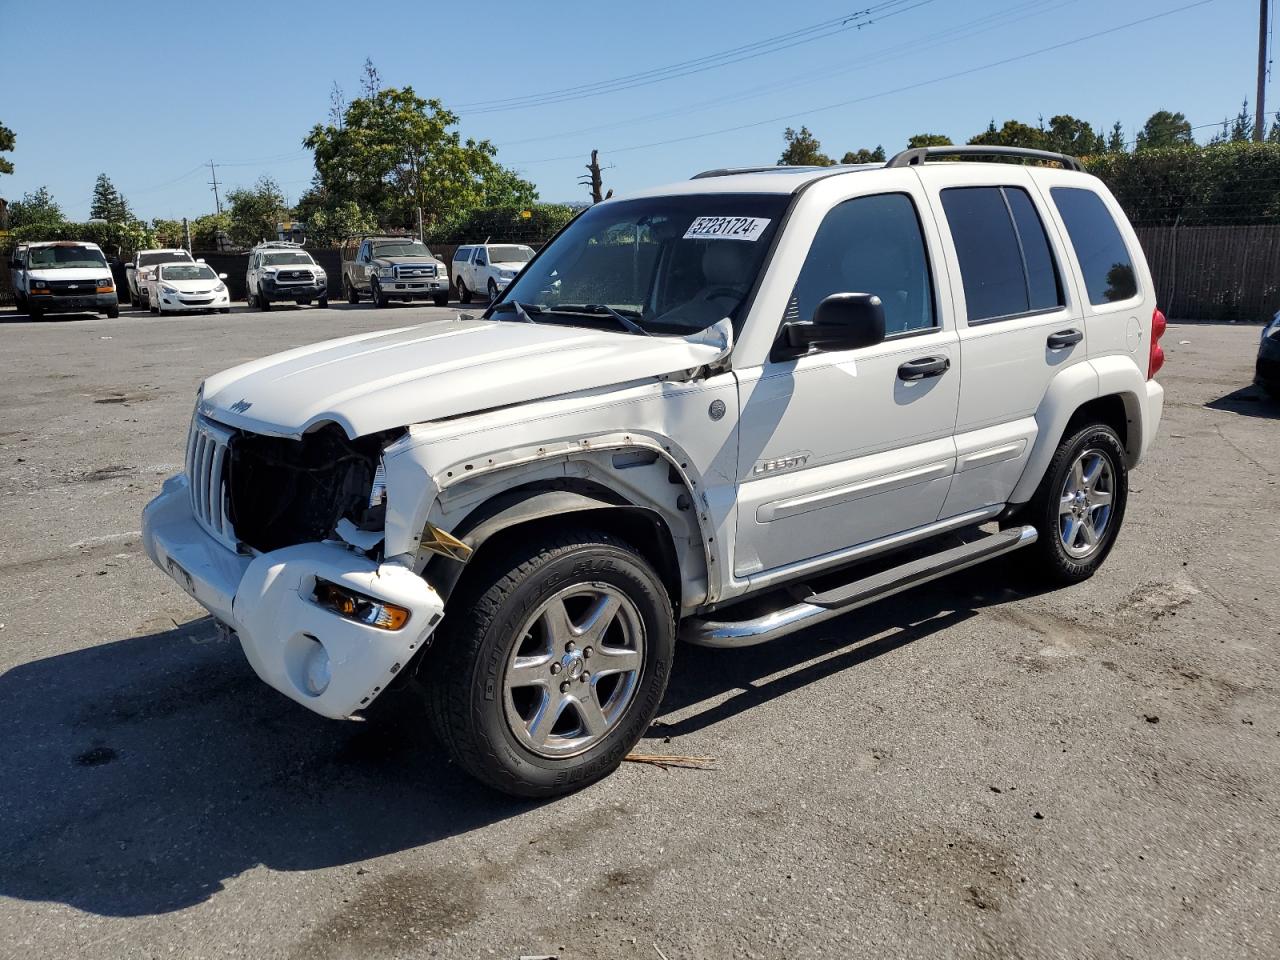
227 424 403 553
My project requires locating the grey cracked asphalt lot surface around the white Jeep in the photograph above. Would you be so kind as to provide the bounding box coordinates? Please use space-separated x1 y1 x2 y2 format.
0 307 1280 960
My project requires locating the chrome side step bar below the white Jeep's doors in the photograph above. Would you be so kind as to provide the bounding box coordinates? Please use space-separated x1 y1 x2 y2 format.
681 526 1037 646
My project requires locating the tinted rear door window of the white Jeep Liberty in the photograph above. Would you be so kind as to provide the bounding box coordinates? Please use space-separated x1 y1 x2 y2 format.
942 187 1062 324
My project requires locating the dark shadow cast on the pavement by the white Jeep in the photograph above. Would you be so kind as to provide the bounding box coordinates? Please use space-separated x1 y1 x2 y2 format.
0 564 1039 916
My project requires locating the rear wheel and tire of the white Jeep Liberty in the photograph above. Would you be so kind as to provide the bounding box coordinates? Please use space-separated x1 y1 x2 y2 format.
1018 424 1129 586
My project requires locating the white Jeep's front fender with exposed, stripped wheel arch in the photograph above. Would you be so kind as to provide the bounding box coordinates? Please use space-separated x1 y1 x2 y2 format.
385 374 737 602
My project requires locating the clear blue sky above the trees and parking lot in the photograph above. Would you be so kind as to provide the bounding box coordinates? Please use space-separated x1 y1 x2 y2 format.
0 0 1259 219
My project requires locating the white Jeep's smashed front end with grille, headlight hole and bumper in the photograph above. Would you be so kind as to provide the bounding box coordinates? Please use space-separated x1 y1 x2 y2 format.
143 413 443 718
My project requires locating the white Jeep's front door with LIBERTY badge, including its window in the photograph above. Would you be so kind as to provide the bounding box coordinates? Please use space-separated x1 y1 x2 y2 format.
733 188 960 577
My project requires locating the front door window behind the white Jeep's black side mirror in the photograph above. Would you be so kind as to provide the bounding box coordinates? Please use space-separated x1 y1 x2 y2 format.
786 193 937 335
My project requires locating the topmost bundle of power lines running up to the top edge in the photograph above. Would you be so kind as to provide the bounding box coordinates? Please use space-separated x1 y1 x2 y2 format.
456 0 934 116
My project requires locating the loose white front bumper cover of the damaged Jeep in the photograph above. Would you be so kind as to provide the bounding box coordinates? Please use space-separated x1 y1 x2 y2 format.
142 475 444 719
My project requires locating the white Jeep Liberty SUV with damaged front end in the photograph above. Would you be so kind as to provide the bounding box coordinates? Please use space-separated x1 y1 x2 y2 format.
143 147 1164 796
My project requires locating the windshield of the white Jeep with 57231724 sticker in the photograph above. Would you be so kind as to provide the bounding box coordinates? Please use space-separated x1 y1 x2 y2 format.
494 193 791 334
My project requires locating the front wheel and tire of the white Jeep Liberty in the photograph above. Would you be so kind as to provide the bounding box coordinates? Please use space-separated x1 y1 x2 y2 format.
420 529 676 797
